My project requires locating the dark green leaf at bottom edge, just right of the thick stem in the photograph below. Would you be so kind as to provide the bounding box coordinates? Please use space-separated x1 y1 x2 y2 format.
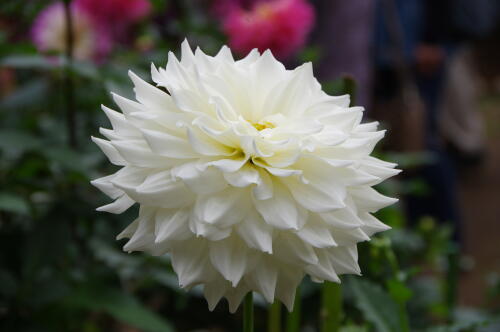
348 278 402 332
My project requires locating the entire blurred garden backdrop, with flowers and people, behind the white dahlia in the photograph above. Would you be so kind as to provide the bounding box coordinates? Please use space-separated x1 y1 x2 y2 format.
0 0 500 332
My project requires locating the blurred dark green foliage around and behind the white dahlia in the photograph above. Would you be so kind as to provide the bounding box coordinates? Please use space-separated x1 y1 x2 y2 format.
0 0 500 332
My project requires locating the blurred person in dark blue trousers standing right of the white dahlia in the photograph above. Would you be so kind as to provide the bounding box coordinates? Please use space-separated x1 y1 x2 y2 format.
374 0 460 241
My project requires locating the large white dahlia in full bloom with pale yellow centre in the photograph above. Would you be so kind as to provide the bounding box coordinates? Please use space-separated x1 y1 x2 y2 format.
92 42 398 312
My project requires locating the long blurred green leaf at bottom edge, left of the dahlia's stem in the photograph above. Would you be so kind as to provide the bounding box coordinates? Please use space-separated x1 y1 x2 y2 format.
67 287 174 332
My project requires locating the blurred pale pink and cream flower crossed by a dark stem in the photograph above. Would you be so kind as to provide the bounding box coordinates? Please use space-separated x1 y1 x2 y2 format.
31 2 112 61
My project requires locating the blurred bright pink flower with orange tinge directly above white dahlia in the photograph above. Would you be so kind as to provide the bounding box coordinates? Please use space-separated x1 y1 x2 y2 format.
223 0 315 58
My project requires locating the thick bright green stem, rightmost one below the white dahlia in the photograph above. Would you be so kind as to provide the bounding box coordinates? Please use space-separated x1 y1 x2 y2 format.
321 281 342 332
